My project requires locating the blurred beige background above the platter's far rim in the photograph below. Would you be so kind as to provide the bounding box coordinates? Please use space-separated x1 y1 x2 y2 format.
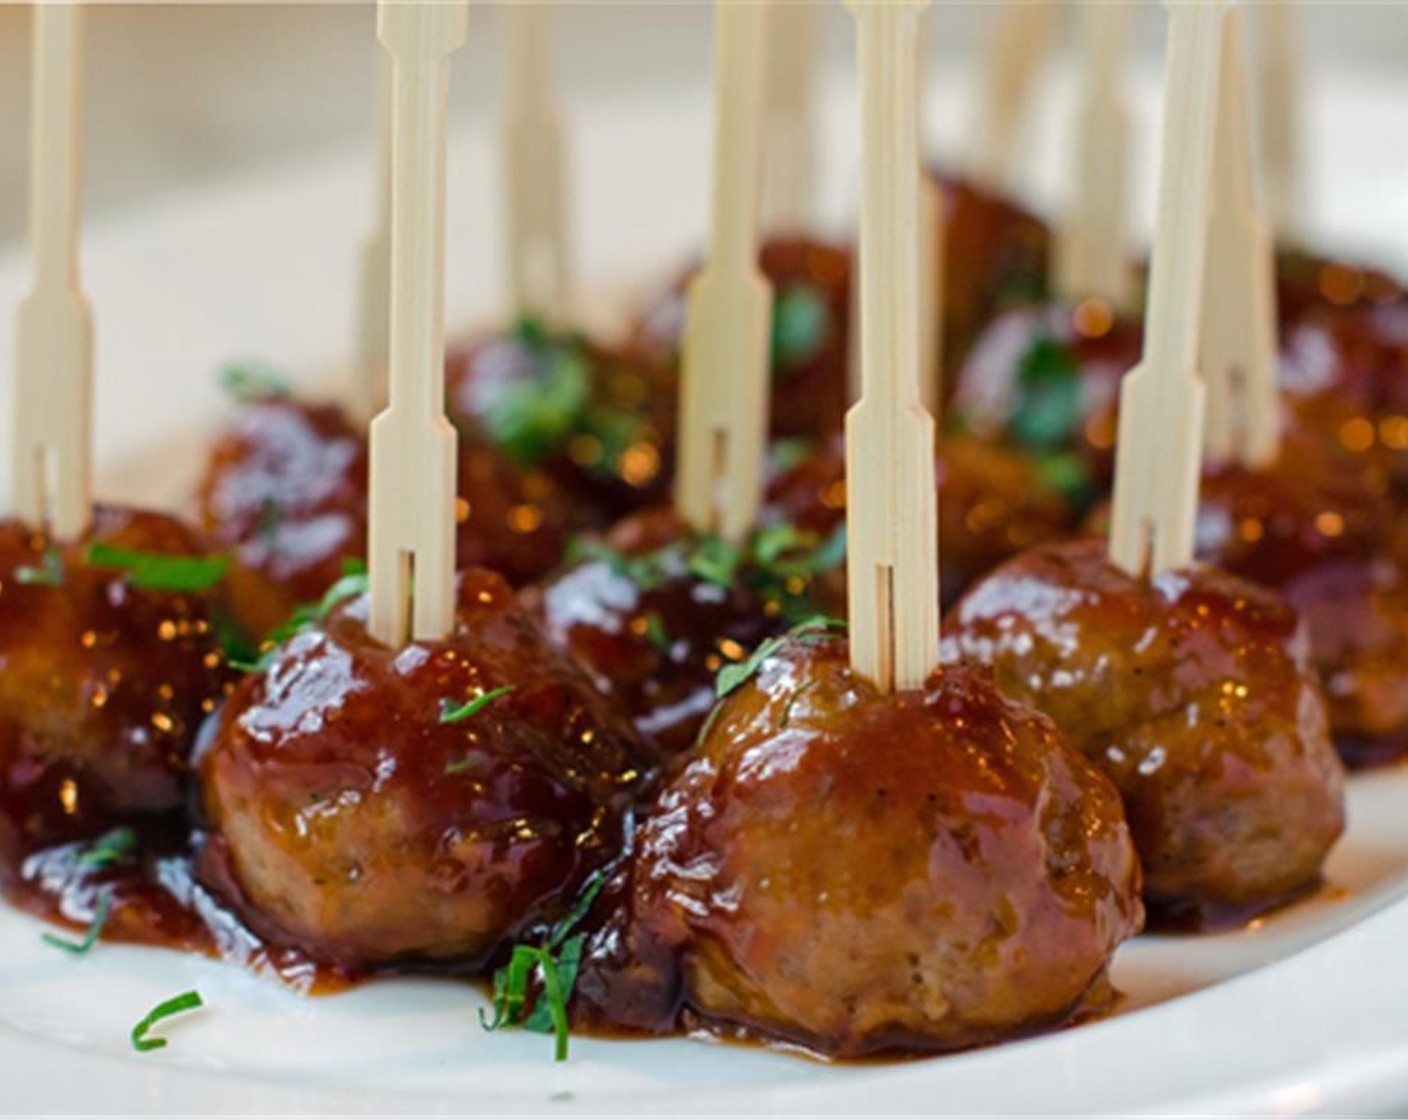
0 0 1408 248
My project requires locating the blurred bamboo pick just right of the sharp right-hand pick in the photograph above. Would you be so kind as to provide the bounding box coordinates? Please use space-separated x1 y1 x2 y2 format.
1200 10 1280 468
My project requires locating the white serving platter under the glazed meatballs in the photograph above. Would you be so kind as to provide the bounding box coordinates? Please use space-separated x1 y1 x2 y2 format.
0 57 1408 1116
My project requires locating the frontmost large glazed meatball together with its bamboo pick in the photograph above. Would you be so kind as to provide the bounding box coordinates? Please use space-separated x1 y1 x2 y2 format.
616 3 1140 1057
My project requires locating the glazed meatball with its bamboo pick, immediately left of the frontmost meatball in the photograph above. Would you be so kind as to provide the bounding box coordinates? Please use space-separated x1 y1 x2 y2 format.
200 0 649 971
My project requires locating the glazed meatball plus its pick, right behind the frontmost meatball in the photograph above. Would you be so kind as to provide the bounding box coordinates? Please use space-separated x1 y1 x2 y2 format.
945 3 1343 923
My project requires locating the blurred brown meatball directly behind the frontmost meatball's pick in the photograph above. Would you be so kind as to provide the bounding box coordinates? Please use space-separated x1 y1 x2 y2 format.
763 435 1087 616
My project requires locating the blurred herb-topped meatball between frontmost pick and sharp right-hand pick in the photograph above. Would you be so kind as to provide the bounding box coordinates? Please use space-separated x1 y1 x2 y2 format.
953 300 1143 494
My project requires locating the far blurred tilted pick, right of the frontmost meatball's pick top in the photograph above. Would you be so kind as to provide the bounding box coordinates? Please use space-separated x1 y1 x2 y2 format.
969 0 1058 192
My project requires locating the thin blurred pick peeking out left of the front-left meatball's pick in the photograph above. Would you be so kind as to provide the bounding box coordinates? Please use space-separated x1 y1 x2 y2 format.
352 49 391 420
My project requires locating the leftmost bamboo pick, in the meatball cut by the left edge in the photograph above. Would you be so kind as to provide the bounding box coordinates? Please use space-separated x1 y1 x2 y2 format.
14 4 93 538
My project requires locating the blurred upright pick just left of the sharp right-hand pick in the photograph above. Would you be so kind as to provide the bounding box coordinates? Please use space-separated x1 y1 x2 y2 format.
1053 4 1131 309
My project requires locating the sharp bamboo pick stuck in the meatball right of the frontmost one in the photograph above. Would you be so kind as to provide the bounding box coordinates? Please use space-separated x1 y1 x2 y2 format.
1110 0 1225 575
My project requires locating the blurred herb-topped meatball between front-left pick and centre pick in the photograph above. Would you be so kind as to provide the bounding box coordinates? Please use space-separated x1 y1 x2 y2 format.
446 320 674 528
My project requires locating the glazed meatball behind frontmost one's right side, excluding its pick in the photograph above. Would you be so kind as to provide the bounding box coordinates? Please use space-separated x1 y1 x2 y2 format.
943 541 1345 921
